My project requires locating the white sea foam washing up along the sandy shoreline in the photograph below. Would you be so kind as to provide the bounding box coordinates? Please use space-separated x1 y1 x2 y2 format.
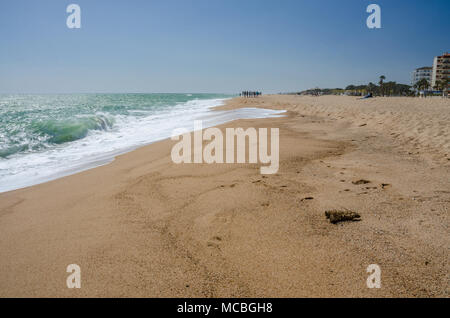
0 99 282 192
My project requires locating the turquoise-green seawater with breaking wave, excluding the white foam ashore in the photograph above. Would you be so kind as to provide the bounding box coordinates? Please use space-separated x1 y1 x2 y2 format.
0 94 227 158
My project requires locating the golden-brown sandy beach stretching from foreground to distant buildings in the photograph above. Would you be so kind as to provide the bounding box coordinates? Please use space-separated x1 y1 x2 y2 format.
0 95 450 297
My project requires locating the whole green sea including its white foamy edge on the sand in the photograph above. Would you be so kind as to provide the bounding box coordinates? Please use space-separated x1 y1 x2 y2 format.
0 94 280 192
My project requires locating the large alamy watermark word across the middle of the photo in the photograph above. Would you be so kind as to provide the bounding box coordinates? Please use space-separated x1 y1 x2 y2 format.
171 121 280 174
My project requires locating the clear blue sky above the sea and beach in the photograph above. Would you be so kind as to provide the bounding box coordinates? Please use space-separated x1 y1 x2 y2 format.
0 0 450 93
